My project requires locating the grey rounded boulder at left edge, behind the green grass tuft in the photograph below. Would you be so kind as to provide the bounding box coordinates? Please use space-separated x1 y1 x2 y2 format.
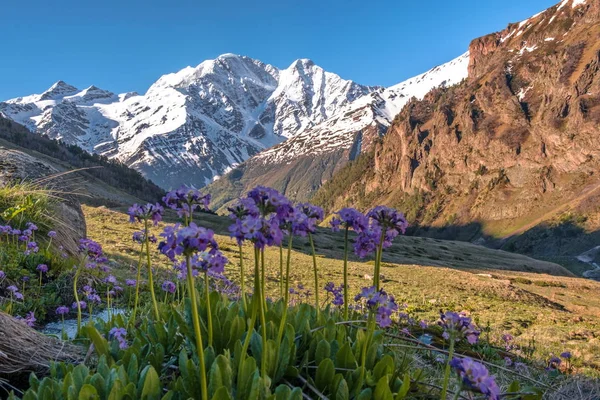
0 146 86 254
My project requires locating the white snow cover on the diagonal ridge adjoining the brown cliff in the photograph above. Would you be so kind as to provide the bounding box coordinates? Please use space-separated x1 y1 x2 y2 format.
253 52 469 164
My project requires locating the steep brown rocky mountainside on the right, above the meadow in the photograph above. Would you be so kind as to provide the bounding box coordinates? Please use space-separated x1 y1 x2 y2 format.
317 0 600 276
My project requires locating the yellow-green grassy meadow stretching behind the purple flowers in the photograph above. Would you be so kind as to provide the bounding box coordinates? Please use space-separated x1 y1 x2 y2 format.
84 207 600 373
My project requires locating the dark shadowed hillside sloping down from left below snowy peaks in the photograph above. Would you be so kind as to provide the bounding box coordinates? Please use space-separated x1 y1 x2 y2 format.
0 117 164 206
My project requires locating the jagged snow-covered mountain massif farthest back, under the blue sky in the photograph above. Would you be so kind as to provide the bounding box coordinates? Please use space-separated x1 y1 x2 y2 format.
0 54 378 188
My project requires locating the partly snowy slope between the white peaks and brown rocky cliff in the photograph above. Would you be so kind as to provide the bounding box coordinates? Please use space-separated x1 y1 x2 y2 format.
207 53 469 211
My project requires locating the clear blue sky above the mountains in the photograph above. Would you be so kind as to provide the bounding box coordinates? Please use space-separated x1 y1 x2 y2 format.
0 0 558 100
